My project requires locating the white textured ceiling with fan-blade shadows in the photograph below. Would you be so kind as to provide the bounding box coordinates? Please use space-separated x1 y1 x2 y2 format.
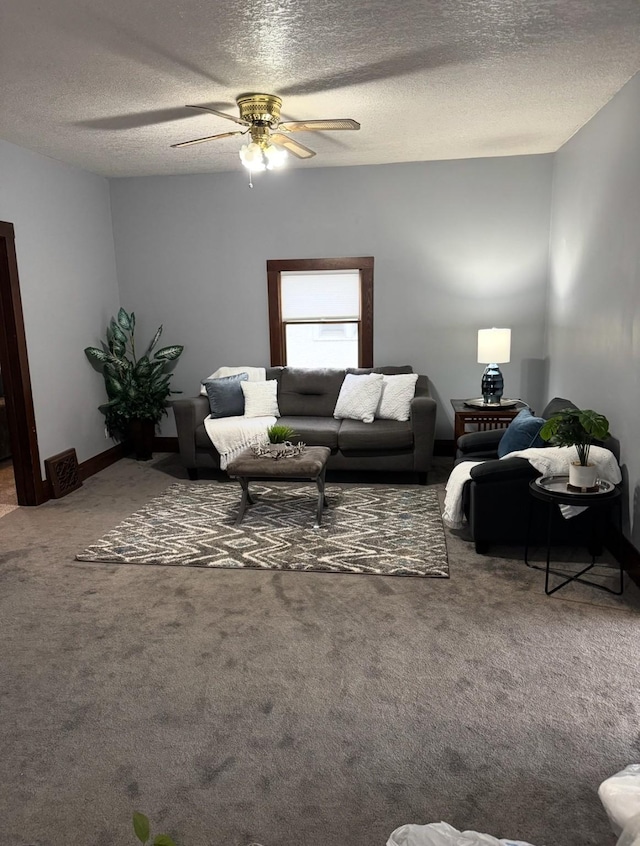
0 0 640 176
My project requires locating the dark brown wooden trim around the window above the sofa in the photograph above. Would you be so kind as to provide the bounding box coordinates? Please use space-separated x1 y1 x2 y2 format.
267 256 373 367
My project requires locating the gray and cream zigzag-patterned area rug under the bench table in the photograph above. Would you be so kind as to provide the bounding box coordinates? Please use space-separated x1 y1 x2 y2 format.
76 482 449 578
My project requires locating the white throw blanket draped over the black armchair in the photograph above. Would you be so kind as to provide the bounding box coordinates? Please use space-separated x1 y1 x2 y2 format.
442 446 622 529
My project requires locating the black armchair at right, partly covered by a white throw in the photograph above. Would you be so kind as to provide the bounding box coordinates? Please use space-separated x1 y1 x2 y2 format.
456 397 604 554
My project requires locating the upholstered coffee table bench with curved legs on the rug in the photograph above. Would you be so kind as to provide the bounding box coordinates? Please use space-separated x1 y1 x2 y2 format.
227 447 331 529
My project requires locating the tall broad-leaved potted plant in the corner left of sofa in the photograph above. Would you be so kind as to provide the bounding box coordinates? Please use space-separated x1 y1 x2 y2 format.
85 308 184 461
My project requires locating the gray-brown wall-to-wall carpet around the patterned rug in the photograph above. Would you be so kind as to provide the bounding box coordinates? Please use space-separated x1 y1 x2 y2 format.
0 455 640 846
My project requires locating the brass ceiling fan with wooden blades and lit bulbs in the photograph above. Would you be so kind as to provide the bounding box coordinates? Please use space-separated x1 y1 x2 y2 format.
171 94 360 170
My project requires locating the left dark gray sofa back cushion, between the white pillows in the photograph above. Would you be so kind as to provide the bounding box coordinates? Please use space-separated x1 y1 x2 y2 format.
278 367 345 417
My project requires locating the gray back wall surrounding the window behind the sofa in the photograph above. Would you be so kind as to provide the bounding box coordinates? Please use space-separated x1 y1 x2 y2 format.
110 156 552 438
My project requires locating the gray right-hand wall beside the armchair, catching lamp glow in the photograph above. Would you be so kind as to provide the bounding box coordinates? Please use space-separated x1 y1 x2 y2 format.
548 75 640 536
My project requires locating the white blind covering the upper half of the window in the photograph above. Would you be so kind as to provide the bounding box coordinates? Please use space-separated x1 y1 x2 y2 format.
280 270 360 323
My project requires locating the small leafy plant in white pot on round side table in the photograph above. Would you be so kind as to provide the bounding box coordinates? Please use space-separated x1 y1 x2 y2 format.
540 408 609 488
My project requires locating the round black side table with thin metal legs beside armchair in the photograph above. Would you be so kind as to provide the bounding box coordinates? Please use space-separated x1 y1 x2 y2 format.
524 476 623 596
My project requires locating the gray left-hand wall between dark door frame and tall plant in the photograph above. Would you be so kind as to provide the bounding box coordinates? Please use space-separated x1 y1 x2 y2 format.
0 141 118 475
